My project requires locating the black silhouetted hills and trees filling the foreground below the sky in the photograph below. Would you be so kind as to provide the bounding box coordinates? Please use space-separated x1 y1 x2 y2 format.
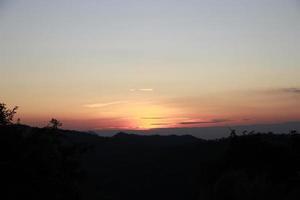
0 125 300 200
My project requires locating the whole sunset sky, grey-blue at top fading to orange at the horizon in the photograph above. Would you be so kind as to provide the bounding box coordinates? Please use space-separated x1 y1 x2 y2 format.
0 0 300 130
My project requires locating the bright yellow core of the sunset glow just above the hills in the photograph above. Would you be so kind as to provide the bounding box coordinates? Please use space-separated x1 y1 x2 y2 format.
88 101 182 130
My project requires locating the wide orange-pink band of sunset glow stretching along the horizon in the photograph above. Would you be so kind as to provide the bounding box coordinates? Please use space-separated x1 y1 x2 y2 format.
14 88 300 130
